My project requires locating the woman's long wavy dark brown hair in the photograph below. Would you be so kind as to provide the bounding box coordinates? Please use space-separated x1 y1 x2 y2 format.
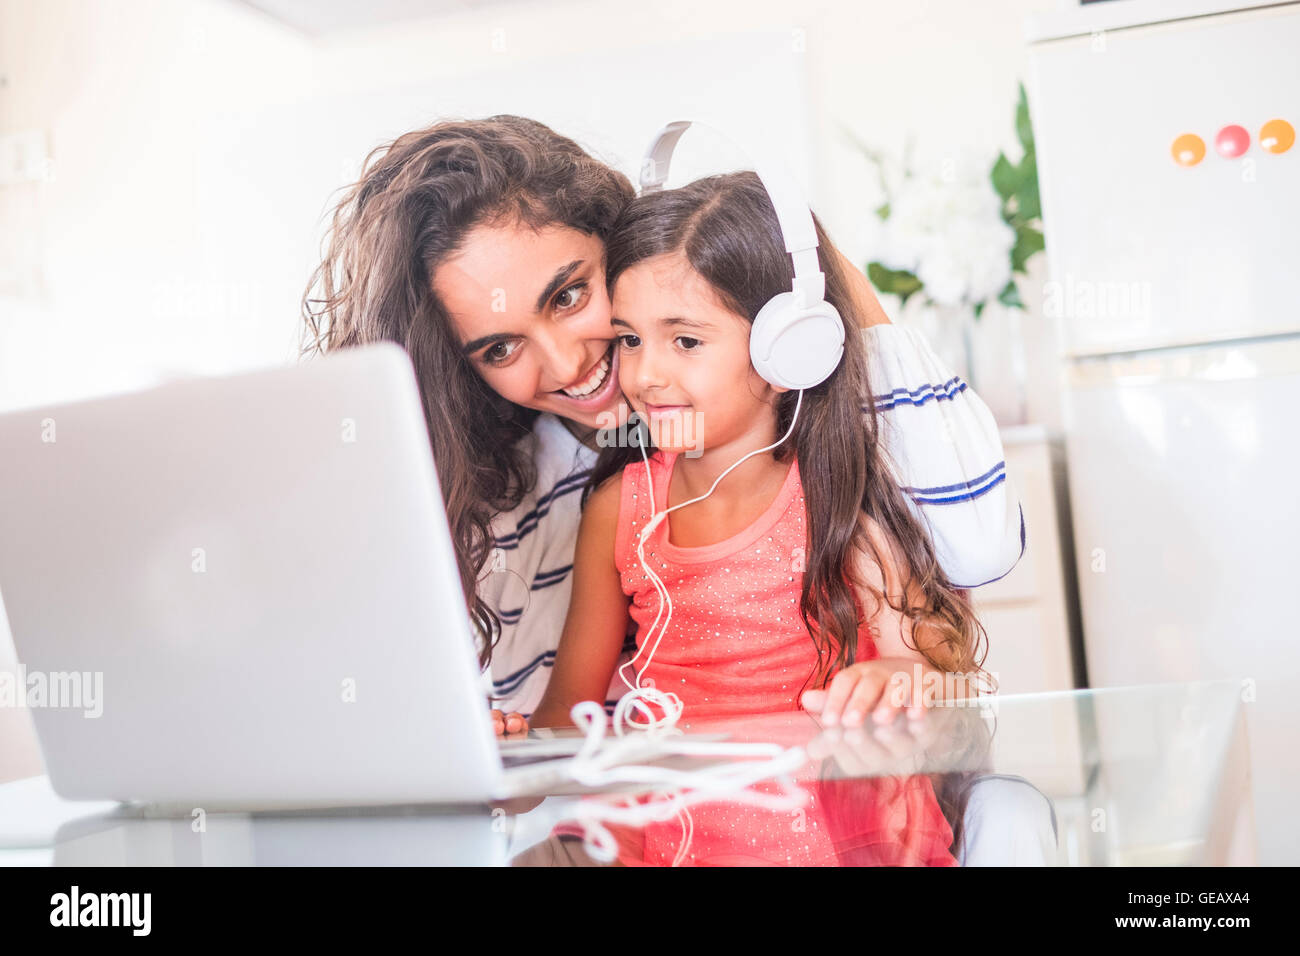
302 116 633 665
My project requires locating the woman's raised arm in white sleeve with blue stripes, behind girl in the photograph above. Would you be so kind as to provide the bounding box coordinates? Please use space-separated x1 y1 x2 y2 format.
836 250 1024 588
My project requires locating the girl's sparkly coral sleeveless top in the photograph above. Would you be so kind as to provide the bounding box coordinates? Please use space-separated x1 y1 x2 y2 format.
614 451 878 721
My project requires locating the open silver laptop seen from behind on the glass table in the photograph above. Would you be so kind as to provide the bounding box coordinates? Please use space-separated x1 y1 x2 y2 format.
0 345 582 809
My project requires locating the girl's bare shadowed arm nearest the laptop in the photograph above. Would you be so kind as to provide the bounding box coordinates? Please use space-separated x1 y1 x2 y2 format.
529 476 628 727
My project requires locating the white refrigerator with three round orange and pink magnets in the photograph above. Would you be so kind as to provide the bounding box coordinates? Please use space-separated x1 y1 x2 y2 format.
1027 0 1300 864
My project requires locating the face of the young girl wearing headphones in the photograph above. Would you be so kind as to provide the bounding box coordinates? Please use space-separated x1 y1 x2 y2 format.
612 254 784 454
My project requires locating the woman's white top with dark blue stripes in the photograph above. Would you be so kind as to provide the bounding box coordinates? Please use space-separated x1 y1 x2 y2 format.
480 325 1024 714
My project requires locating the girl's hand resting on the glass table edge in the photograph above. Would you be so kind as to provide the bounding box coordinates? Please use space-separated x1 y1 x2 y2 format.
801 657 939 727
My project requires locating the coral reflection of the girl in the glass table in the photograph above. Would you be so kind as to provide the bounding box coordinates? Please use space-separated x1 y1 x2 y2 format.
512 708 1003 866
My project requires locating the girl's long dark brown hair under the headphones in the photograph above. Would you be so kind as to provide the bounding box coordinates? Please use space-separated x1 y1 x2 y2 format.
588 172 983 684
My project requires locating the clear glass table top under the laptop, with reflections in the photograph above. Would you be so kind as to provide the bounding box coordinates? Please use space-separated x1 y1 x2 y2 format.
0 682 1256 866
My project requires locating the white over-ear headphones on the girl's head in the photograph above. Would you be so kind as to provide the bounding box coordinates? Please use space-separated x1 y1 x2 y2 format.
641 120 844 390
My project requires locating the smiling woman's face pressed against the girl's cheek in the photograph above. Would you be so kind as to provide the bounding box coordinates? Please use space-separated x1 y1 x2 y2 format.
433 224 621 428
